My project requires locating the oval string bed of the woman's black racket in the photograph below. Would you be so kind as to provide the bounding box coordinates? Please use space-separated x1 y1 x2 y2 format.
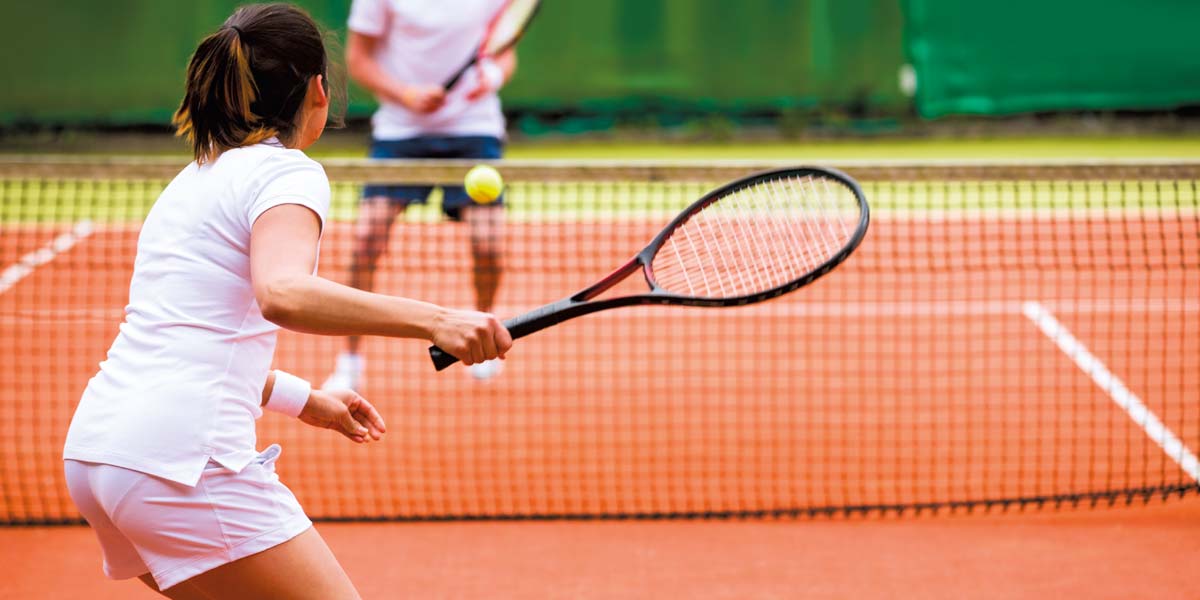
652 175 860 299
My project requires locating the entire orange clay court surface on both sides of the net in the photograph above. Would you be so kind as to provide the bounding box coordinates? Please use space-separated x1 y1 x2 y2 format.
0 218 1200 599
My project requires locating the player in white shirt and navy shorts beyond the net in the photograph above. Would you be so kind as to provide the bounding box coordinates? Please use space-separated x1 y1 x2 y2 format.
323 0 516 390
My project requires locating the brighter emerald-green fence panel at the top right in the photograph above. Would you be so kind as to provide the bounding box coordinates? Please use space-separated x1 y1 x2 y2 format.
904 0 1200 118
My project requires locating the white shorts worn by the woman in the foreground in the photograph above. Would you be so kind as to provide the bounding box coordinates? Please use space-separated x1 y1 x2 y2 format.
65 444 312 589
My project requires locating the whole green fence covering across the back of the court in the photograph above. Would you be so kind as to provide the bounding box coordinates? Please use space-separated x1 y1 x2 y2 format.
0 0 1200 127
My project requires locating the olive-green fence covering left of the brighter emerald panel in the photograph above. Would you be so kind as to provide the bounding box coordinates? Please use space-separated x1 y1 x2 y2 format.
0 0 908 124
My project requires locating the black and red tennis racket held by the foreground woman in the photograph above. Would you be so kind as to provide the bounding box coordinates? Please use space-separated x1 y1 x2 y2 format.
430 168 870 371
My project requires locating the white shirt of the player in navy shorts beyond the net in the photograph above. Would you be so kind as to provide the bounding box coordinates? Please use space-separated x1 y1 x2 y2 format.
348 0 504 139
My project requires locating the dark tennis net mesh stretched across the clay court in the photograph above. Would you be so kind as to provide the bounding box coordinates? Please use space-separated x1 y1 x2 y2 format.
0 158 1200 523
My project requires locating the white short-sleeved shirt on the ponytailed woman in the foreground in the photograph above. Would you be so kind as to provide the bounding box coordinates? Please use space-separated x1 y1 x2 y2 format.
64 139 330 485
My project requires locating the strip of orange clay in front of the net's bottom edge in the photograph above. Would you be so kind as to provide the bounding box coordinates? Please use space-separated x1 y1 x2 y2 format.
0 497 1200 600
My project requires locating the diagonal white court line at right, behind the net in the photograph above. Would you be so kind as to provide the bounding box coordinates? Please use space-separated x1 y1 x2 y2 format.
1022 302 1200 482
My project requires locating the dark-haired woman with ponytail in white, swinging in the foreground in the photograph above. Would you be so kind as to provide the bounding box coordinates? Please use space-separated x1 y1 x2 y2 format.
64 5 511 599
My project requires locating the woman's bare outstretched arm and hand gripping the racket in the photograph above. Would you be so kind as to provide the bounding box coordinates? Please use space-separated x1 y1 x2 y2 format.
250 204 512 365
